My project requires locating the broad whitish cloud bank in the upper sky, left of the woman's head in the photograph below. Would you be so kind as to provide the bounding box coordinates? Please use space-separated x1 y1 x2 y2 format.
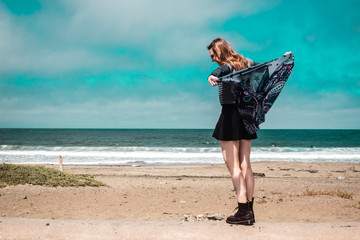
0 0 280 75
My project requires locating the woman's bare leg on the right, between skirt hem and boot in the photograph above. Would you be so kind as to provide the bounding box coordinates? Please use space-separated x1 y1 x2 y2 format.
239 140 255 201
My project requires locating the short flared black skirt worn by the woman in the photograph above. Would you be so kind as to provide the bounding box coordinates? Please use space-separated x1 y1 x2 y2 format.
212 104 257 141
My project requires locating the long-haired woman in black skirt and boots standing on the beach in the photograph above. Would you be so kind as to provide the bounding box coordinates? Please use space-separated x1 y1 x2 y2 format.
207 38 257 225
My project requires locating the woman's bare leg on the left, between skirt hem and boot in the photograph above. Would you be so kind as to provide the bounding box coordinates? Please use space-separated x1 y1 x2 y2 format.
220 141 247 203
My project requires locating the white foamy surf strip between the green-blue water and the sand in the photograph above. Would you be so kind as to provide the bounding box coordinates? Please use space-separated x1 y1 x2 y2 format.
0 145 360 165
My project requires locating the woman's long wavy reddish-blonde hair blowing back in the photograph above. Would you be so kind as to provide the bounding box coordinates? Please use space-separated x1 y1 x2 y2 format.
207 38 248 70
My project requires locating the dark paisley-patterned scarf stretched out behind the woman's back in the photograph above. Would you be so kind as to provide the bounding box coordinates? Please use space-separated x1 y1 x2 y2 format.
219 54 294 134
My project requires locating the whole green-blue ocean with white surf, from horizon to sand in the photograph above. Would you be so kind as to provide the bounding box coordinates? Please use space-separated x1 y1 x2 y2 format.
0 129 360 166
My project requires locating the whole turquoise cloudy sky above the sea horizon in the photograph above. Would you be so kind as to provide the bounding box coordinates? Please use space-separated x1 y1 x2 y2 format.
0 0 360 129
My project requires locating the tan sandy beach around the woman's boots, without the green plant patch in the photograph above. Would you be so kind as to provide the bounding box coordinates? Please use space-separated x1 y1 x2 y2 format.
0 162 360 239
